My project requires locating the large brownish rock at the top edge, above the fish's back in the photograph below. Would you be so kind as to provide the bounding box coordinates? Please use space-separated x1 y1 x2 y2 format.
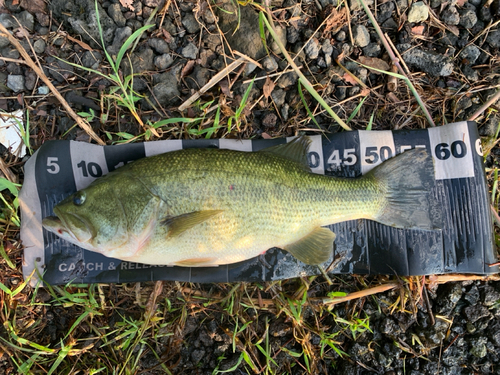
216 0 266 60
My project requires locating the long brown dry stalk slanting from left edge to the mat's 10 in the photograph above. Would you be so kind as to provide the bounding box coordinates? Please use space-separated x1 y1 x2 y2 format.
0 24 105 145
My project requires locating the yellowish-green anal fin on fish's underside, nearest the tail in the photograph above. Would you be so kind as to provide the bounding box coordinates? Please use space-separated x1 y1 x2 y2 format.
284 227 336 265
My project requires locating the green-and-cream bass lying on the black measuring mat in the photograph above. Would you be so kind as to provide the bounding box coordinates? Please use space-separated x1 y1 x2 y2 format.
42 136 434 267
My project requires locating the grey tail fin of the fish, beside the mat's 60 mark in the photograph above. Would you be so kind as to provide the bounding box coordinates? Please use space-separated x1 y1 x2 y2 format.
370 148 435 229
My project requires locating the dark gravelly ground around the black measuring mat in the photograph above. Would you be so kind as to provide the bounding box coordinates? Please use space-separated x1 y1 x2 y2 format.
0 0 500 375
